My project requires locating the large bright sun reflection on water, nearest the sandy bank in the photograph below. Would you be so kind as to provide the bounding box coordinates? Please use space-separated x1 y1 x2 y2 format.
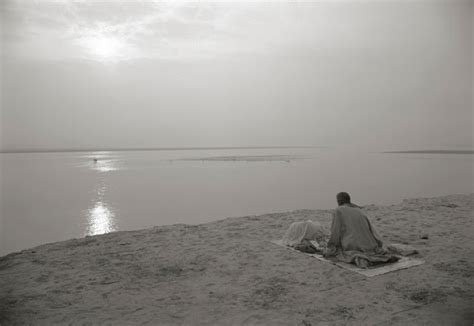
85 185 116 235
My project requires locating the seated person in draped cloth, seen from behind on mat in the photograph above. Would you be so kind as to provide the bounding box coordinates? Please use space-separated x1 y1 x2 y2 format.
325 192 398 268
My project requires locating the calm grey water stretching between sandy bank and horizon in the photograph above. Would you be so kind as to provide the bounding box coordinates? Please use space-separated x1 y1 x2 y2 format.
0 149 474 255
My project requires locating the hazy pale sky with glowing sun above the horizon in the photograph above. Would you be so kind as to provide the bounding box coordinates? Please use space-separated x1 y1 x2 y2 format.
0 0 474 150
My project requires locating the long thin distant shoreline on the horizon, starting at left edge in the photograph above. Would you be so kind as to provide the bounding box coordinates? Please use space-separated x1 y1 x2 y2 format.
0 146 327 154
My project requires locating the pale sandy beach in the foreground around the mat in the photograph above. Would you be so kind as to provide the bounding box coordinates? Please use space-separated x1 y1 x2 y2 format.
0 195 474 325
